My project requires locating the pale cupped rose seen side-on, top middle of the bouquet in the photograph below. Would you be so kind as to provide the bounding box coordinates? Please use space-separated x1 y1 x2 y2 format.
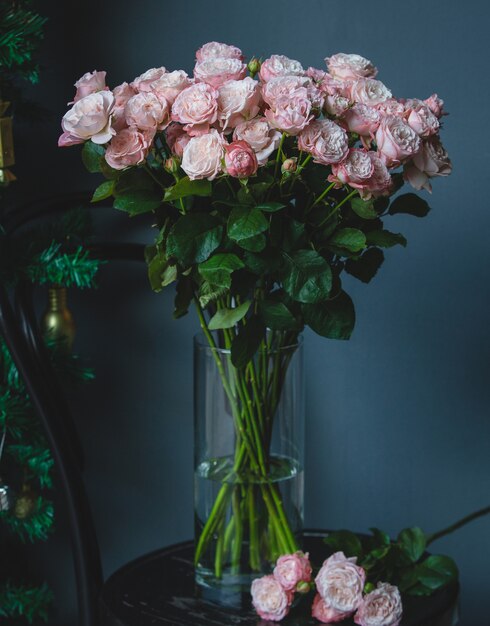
218 76 261 130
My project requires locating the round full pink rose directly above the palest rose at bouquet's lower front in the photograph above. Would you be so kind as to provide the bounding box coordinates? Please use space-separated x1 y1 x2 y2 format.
172 83 219 135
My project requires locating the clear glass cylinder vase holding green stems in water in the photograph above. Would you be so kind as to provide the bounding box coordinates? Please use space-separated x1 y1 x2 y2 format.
194 333 304 601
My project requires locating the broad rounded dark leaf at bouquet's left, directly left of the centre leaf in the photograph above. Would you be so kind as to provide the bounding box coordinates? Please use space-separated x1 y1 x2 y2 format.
167 213 223 267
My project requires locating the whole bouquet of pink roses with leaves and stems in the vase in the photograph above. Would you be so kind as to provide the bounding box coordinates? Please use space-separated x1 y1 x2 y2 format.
59 42 451 579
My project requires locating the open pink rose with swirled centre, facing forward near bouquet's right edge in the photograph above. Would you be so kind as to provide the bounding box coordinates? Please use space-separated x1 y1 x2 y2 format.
376 115 421 167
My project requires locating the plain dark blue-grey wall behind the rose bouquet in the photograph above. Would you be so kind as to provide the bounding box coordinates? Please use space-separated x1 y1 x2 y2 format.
4 0 490 626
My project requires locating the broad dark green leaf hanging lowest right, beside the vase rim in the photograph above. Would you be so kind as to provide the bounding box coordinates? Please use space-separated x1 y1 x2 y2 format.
303 291 356 339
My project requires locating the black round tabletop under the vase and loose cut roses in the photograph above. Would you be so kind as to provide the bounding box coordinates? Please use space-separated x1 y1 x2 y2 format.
101 531 458 626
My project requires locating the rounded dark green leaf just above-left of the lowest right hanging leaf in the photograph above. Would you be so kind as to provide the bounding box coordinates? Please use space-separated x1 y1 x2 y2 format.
282 250 332 303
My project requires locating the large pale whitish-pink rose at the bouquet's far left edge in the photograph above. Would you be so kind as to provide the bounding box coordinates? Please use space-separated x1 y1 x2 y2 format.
60 91 116 145
